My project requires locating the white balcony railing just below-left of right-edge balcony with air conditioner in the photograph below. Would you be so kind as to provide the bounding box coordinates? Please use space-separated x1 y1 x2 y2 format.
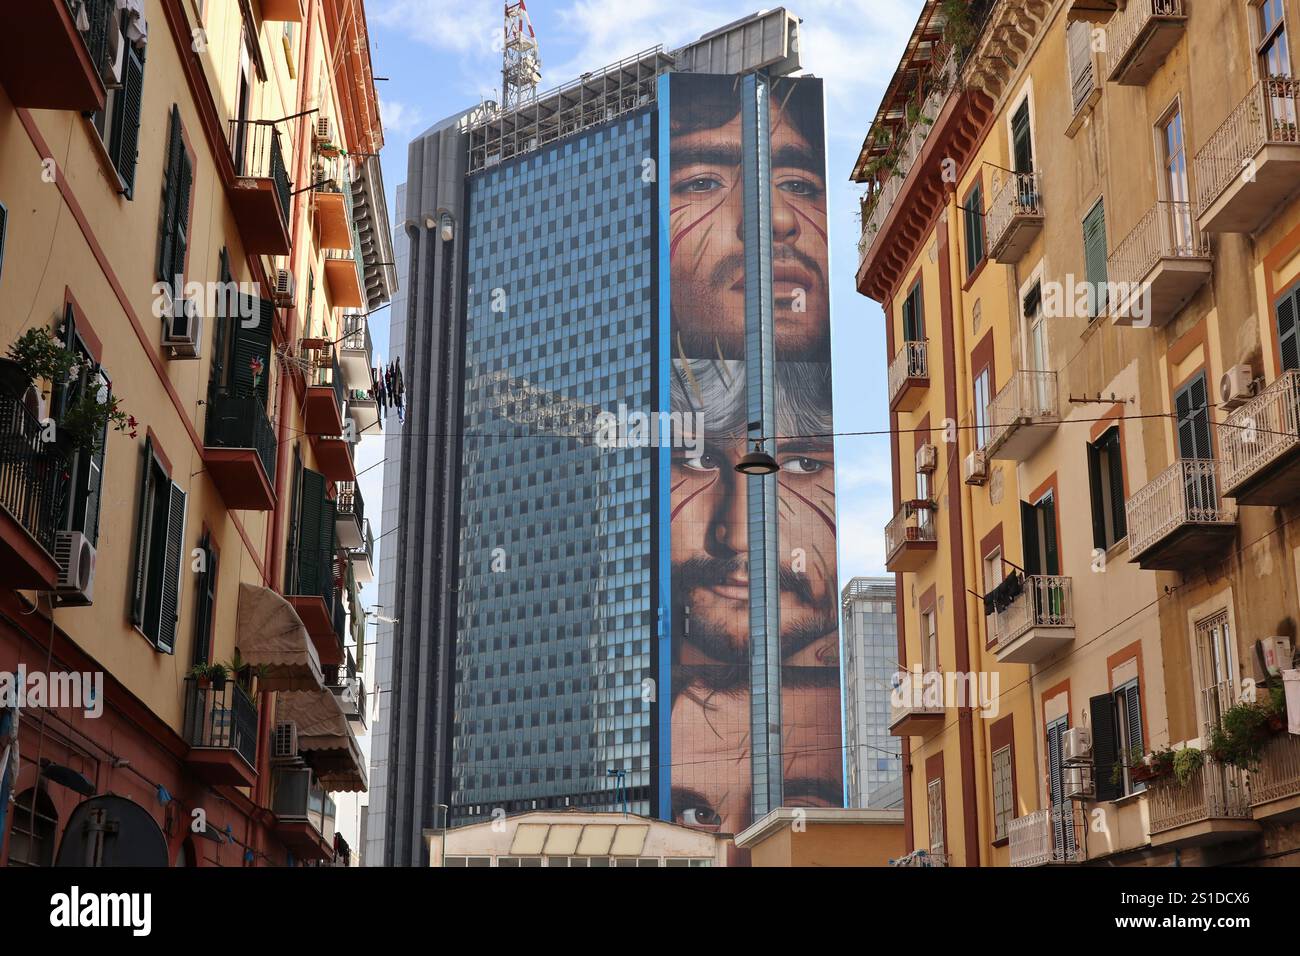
1126 458 1236 555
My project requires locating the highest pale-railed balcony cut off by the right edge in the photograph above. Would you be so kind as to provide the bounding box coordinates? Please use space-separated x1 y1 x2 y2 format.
1195 77 1300 233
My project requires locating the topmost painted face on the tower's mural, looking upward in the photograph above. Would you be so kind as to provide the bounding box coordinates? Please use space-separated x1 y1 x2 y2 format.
670 100 829 362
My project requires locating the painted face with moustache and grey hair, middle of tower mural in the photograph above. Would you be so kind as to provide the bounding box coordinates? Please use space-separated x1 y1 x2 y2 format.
672 434 839 665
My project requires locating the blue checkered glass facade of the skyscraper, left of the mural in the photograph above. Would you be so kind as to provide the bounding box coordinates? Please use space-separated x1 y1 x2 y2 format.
451 111 657 823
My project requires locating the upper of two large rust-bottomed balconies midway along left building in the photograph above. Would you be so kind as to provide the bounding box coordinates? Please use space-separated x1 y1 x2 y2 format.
230 120 291 256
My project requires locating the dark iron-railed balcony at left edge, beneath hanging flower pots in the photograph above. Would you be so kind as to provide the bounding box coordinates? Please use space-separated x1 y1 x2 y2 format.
0 392 69 591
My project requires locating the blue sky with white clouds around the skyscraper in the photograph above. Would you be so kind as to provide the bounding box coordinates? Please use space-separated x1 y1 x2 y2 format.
358 0 920 604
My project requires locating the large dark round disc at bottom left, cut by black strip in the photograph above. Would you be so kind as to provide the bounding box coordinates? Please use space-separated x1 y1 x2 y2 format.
55 796 168 866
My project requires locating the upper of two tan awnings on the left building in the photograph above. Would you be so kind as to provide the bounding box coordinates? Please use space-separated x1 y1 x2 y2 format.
235 583 325 691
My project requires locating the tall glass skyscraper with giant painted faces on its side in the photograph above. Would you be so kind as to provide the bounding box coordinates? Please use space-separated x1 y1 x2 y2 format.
371 9 841 865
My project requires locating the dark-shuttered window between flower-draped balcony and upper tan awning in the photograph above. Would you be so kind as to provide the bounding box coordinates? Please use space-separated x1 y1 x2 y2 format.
131 436 186 654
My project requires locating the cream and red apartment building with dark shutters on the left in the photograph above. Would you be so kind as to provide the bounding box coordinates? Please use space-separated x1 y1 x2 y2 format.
0 0 395 866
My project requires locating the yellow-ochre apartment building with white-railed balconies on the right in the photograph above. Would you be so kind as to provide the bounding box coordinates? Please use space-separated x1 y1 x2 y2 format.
854 0 1300 866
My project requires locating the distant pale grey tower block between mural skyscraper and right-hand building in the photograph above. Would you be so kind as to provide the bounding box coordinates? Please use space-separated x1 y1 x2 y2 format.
841 578 902 806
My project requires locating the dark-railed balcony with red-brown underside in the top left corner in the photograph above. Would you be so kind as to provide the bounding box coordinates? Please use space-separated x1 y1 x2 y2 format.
0 0 117 113
